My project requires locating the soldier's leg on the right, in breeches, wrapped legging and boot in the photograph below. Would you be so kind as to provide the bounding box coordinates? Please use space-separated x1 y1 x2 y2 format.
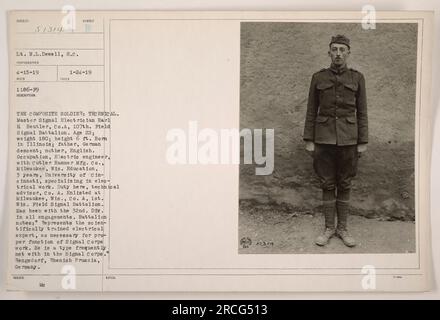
336 145 358 247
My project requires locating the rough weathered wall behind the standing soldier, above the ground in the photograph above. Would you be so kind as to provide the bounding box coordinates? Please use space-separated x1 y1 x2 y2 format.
240 22 417 220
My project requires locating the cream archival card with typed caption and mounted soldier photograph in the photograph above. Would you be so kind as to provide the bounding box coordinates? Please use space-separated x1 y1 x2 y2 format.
0 8 434 296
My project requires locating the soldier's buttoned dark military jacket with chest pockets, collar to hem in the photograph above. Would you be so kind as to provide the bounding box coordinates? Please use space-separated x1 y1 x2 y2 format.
304 67 368 146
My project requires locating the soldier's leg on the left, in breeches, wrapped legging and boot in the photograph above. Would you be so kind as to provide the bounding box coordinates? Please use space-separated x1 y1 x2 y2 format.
313 144 336 246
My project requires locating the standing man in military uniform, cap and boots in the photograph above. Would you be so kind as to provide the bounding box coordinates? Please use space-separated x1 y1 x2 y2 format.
304 35 368 247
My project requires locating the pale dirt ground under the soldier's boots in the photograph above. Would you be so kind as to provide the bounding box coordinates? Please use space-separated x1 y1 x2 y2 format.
239 205 415 254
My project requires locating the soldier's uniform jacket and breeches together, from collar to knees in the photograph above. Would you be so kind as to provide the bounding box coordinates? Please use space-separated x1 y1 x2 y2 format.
303 66 368 192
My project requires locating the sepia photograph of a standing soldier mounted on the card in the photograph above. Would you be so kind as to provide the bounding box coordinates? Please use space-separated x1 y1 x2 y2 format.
238 21 418 254
